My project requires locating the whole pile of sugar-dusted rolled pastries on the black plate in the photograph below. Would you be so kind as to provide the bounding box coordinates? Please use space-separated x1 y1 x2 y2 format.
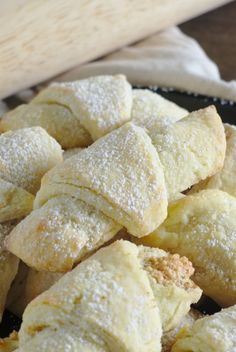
0 75 236 352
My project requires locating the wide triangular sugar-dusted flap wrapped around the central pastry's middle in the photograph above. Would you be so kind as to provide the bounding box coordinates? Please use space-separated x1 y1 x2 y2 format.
35 123 167 237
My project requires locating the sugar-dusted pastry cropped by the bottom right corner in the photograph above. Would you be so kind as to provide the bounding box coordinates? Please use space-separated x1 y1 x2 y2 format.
171 305 236 352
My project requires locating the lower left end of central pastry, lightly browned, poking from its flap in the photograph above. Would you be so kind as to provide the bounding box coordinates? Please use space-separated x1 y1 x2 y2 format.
5 196 121 272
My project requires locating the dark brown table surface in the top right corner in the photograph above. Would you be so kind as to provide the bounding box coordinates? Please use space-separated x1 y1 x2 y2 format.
180 1 236 80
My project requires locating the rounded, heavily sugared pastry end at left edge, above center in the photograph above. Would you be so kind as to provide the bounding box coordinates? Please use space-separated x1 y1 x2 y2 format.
0 127 62 194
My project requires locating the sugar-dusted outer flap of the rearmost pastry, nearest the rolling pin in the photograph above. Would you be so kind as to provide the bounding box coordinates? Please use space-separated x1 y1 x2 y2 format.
36 75 132 141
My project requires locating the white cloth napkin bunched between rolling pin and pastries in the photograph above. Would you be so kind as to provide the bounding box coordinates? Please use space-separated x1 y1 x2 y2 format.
54 27 236 101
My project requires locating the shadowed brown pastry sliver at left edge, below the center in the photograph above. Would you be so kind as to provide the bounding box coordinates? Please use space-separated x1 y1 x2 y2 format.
0 222 19 321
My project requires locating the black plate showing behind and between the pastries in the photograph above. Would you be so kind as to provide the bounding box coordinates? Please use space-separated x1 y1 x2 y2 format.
0 87 236 337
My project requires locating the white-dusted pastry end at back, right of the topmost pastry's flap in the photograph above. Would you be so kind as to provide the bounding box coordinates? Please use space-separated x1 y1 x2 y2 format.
131 89 188 133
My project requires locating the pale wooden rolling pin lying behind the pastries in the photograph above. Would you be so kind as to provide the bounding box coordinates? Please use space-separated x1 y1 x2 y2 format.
0 0 232 98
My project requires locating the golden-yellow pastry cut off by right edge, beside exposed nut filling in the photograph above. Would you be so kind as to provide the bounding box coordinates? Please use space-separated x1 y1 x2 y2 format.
143 190 236 306
